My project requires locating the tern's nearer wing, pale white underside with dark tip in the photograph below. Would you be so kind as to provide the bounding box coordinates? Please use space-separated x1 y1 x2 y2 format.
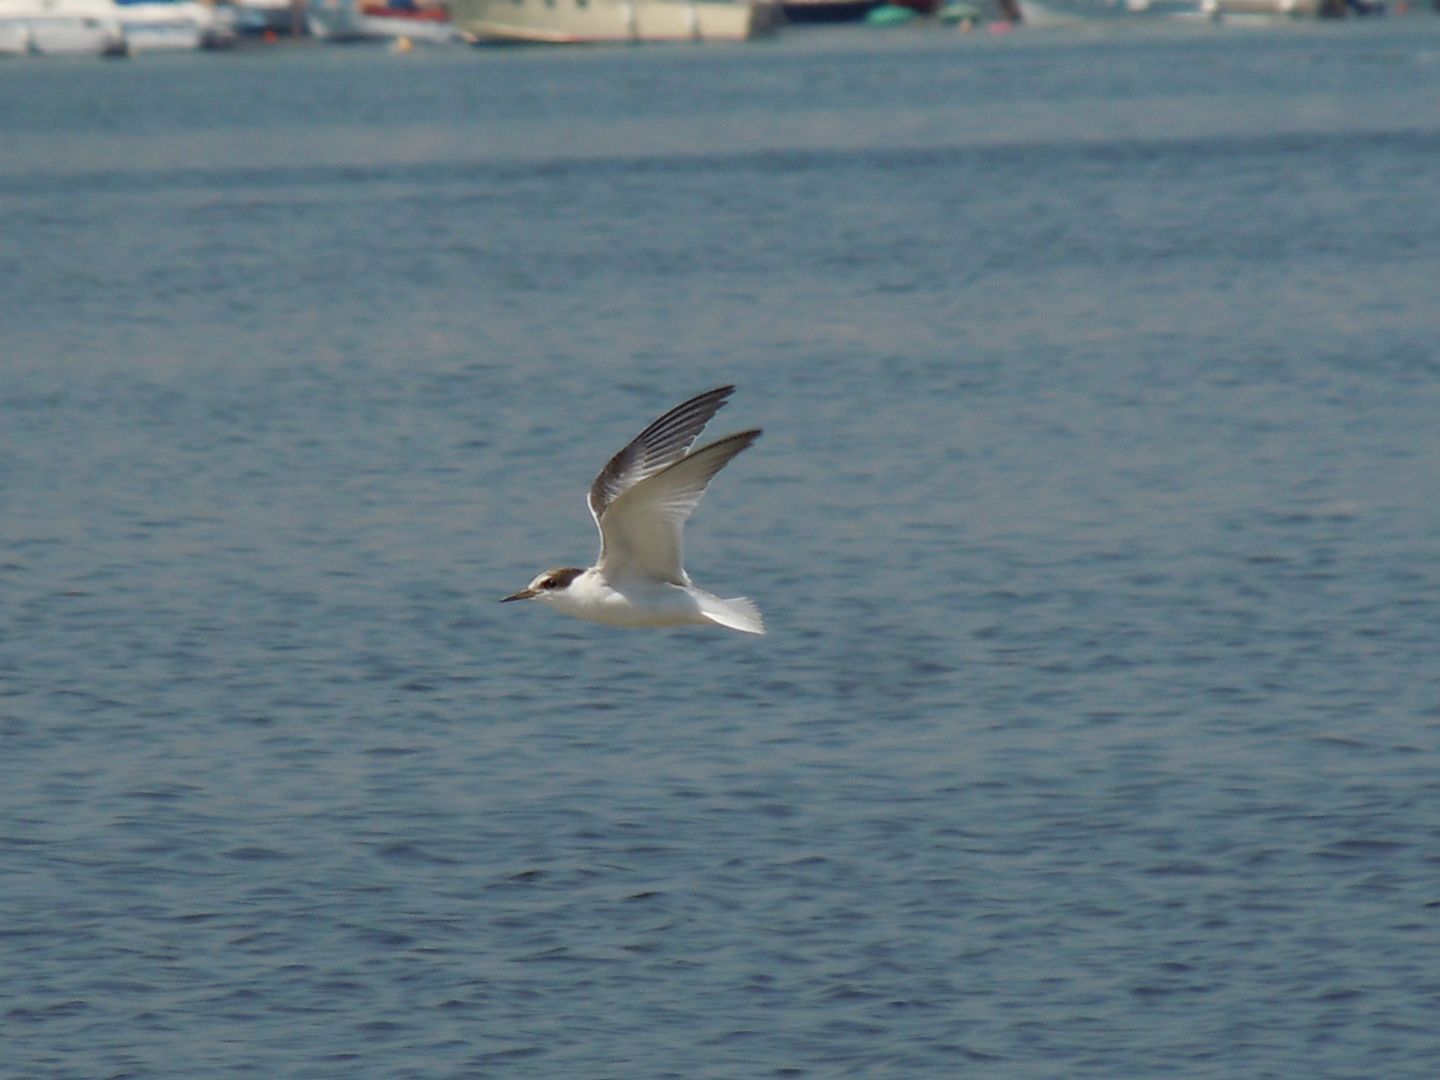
592 426 760 585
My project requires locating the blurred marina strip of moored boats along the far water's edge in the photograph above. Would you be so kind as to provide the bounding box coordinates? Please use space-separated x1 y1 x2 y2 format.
0 0 1416 58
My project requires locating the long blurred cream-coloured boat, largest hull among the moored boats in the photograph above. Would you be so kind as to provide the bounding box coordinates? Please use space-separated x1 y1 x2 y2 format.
451 0 779 43
